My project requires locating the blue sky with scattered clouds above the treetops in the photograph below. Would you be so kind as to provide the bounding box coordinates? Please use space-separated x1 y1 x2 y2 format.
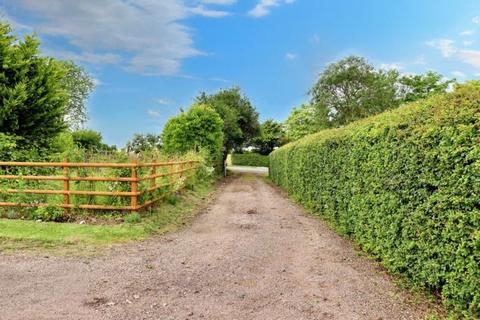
0 0 480 146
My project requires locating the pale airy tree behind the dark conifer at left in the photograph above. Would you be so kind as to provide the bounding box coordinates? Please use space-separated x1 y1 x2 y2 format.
58 61 95 130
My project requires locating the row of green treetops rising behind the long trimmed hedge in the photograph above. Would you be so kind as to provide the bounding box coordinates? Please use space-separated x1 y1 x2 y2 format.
285 56 455 141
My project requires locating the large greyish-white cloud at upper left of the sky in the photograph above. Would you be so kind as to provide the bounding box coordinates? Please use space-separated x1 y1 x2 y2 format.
3 0 234 75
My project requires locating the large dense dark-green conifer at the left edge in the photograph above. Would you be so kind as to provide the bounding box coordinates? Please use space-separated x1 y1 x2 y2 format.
0 22 67 147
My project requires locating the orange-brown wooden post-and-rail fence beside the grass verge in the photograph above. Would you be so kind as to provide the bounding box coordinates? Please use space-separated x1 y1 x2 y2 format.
0 160 198 214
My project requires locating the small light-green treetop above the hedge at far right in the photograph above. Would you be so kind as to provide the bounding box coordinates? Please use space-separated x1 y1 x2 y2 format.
398 71 455 103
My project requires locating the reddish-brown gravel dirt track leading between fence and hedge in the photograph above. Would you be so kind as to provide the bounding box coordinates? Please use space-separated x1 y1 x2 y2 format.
0 176 423 320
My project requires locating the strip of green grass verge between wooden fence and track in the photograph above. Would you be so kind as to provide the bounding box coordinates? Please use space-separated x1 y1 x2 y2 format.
0 181 214 255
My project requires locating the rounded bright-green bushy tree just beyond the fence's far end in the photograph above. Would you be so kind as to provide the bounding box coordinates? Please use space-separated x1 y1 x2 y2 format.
162 104 223 163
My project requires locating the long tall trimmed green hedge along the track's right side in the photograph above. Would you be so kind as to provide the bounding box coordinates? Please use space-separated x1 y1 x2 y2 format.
270 82 480 319
